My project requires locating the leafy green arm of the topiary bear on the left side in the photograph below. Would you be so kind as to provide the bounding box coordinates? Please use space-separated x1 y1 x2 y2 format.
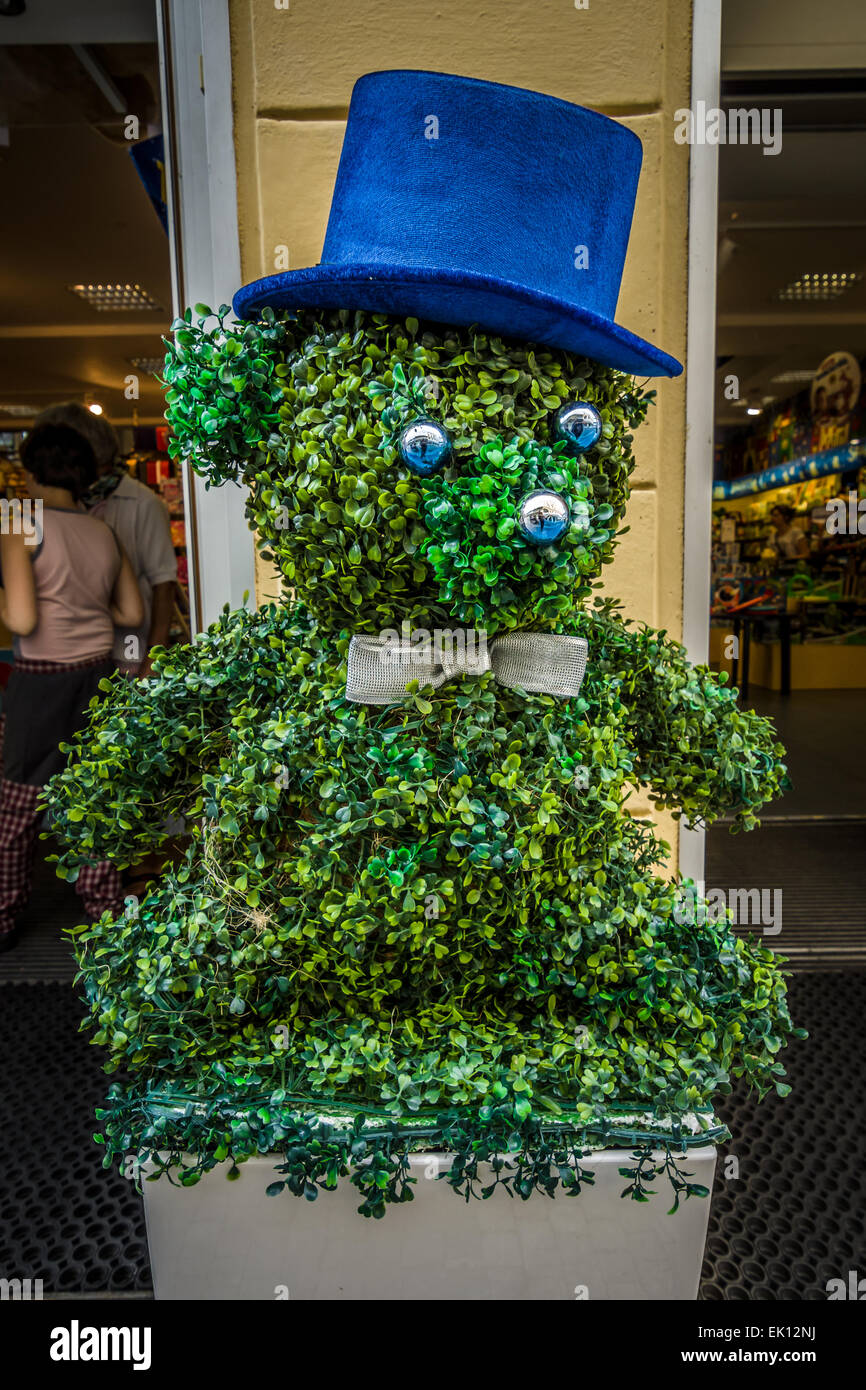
44 607 303 877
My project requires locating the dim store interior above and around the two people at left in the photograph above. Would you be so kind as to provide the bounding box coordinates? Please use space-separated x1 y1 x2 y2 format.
0 33 189 684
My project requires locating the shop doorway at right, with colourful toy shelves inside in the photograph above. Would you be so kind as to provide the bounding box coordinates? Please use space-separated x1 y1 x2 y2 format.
708 70 866 969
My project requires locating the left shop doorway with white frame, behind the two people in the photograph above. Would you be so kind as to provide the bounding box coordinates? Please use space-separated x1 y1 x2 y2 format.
0 0 246 981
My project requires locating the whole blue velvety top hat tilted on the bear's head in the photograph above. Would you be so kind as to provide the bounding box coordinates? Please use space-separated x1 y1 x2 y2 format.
234 71 683 377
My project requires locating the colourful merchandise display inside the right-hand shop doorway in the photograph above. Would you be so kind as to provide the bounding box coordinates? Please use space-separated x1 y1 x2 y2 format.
710 352 866 656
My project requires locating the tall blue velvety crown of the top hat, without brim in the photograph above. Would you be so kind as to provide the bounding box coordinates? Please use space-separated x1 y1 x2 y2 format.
321 70 641 318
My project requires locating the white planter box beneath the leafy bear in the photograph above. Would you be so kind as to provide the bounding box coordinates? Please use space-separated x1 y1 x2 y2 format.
143 1147 716 1301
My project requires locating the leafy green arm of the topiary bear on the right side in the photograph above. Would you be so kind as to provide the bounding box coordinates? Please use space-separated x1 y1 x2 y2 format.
578 610 788 830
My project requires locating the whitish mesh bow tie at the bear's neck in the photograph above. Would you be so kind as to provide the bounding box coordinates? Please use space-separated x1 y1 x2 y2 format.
346 632 587 705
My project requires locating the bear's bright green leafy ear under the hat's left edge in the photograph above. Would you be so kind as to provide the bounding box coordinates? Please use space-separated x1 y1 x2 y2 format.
161 304 295 487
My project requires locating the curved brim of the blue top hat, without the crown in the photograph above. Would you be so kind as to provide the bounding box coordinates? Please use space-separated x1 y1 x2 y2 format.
232 263 683 377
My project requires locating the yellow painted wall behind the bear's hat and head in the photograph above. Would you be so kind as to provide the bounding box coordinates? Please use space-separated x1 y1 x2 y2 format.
229 0 691 837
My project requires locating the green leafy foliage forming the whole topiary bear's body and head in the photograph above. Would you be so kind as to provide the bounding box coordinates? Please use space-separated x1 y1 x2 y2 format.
47 306 796 1216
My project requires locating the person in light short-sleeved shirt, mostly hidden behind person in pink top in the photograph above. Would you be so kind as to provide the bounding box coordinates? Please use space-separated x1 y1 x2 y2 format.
36 400 178 676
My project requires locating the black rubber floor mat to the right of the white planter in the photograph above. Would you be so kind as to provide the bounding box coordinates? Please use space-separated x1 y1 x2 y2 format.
700 973 866 1301
